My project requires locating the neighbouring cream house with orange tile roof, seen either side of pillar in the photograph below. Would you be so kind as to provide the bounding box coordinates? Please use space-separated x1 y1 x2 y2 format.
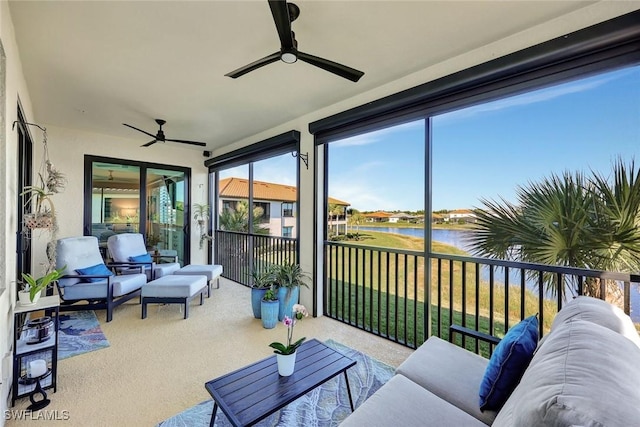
219 177 349 238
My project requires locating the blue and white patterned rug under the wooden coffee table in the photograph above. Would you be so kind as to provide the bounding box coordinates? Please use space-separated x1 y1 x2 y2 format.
158 340 394 427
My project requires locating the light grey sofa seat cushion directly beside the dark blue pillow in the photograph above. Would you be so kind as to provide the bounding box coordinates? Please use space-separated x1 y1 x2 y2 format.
396 336 496 425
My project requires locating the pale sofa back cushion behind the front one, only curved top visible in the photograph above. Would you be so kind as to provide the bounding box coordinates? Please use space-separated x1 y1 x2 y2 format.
551 296 640 347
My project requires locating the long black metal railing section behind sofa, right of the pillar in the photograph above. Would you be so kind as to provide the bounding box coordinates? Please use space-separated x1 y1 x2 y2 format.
324 242 640 355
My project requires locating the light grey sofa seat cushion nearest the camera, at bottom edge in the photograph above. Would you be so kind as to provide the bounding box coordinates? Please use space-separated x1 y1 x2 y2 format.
340 375 485 427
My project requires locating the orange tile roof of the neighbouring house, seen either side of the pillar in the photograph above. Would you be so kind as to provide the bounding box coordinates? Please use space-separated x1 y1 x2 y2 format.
219 177 350 206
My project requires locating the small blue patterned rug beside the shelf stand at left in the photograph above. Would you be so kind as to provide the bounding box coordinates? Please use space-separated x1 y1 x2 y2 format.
58 310 109 360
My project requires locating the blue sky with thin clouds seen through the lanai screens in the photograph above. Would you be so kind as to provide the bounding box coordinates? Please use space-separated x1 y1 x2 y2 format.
221 66 640 211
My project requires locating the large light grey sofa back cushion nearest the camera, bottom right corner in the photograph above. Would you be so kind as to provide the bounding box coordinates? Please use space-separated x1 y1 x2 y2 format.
493 320 640 427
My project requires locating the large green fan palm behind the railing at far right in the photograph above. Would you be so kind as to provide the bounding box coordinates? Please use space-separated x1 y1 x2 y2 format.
468 160 640 296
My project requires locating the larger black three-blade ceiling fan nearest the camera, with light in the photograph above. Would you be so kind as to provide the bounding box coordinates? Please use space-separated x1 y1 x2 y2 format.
225 0 364 82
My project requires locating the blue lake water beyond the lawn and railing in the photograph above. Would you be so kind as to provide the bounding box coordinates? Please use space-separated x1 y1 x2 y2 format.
360 227 640 322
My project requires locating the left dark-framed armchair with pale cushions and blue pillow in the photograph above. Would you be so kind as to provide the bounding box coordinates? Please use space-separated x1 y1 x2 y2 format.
56 236 147 322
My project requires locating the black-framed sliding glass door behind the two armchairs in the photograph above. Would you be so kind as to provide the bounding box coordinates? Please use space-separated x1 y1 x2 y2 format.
84 156 190 265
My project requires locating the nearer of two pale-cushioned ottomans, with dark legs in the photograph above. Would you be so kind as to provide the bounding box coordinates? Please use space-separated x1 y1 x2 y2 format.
141 275 208 319
